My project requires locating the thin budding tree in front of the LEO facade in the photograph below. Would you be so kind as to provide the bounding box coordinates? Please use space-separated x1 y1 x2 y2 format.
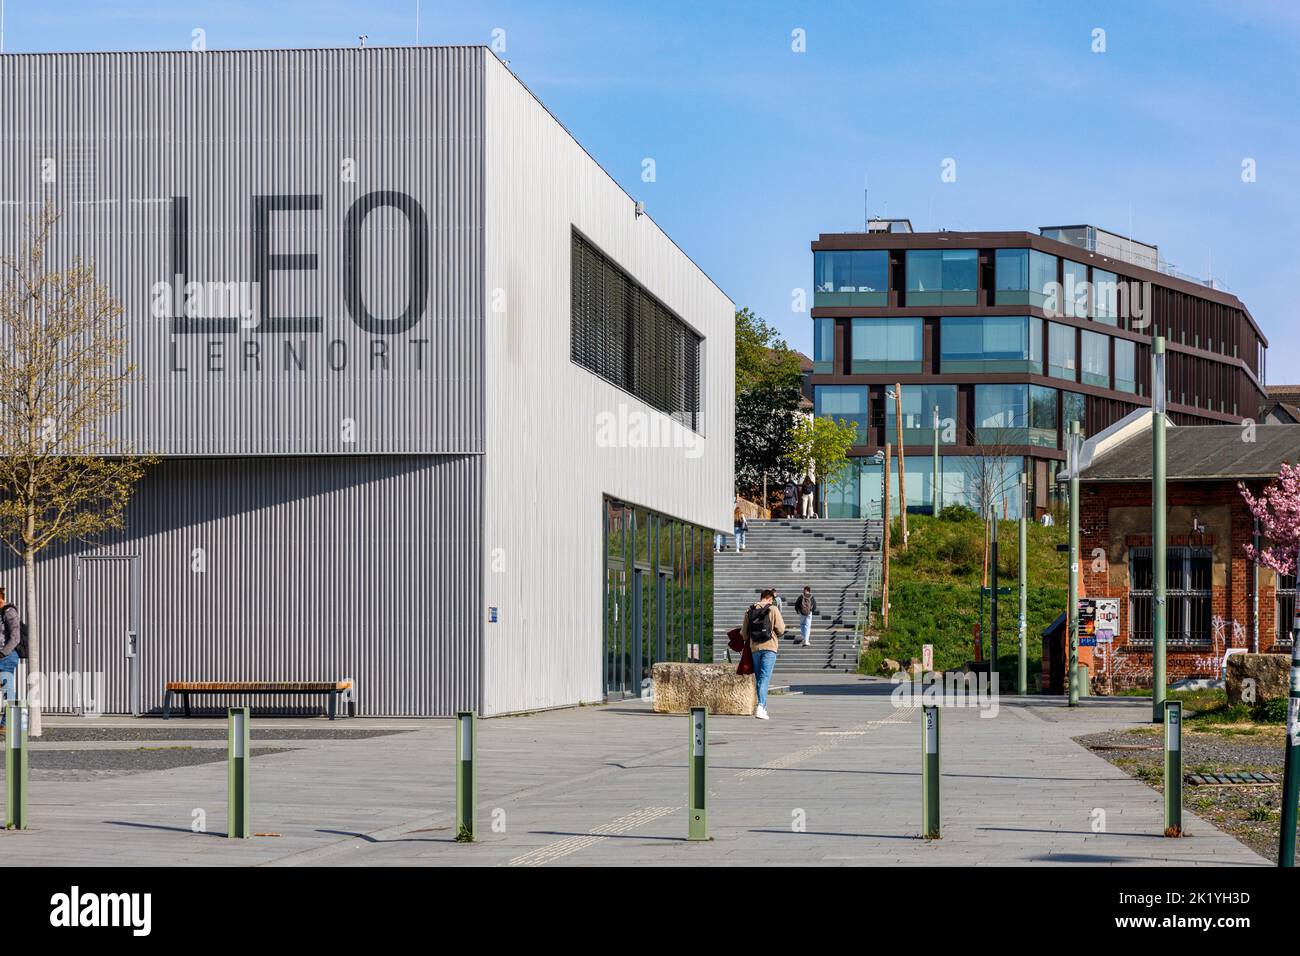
0 207 152 736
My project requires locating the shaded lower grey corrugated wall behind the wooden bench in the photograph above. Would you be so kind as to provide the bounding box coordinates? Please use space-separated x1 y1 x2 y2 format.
0 455 482 717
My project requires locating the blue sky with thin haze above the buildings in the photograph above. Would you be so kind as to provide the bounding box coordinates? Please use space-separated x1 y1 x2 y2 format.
5 0 1300 382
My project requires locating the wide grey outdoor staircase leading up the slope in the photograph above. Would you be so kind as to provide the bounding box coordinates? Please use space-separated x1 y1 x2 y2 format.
714 519 884 676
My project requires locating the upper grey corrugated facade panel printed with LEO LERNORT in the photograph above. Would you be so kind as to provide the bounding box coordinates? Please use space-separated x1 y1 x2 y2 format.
0 47 484 455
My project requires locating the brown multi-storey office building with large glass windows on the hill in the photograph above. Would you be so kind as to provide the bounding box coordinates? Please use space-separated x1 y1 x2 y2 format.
813 220 1268 516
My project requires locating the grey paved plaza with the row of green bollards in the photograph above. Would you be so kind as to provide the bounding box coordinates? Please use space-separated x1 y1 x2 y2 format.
0 675 1266 866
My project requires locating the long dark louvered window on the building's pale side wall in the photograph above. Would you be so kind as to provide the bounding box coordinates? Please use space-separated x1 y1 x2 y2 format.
569 233 701 432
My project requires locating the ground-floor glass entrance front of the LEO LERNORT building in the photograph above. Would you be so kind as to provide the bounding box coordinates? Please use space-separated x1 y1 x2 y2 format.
603 498 714 697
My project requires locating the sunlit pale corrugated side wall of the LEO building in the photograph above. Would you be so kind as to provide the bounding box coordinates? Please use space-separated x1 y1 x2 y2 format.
484 56 735 714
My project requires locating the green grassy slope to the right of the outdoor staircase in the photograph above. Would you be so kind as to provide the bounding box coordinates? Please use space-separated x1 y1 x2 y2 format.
862 515 1069 691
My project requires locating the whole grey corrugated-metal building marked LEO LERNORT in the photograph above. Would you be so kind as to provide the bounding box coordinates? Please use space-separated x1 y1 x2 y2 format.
0 47 735 715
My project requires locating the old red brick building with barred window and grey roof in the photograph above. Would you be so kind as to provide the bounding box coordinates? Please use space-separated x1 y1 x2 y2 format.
1044 411 1300 693
